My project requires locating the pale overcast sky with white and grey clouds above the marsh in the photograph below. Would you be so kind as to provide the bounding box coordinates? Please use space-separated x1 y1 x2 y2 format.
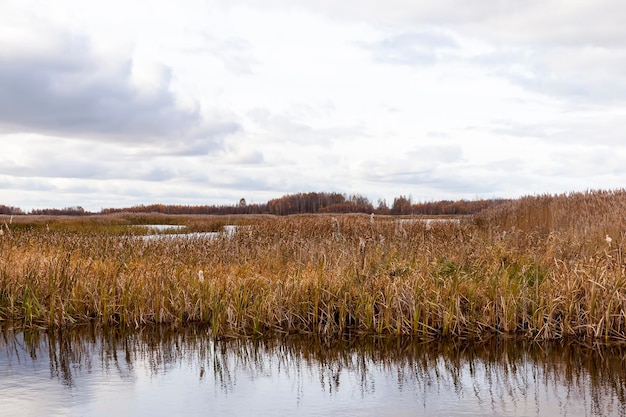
0 0 626 211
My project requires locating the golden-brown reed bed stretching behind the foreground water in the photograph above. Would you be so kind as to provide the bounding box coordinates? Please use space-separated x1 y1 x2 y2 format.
0 191 626 341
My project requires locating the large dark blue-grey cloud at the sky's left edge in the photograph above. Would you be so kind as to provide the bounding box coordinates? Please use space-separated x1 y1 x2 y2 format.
0 30 240 154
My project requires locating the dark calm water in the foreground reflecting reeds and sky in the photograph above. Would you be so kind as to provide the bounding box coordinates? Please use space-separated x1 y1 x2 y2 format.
0 327 626 416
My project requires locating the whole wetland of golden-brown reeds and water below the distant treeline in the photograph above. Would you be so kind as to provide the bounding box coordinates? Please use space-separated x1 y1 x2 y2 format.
0 191 626 416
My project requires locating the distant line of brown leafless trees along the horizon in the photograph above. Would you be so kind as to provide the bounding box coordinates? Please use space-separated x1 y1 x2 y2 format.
0 192 510 216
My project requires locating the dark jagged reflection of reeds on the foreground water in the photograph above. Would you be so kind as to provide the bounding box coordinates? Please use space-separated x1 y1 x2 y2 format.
0 327 626 415
